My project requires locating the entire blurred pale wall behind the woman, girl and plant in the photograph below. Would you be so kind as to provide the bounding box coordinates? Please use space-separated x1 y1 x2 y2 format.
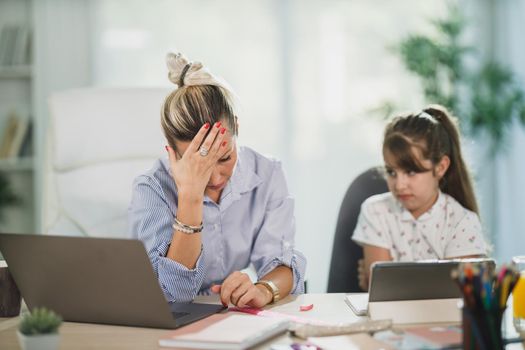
34 0 525 292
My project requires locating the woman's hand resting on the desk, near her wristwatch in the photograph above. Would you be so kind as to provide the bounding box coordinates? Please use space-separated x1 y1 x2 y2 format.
211 271 273 308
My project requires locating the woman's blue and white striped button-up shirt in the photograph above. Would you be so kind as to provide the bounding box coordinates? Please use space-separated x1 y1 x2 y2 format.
129 147 306 302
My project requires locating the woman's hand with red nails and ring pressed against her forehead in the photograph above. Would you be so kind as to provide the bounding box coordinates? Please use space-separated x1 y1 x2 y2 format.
166 122 227 199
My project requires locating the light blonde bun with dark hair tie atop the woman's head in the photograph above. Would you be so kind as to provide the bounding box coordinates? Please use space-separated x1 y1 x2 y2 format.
166 52 212 88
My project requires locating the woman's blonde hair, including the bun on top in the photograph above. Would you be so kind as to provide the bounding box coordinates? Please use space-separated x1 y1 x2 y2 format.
161 53 237 149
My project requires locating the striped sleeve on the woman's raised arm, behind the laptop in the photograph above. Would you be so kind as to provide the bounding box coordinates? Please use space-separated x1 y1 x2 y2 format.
129 175 206 302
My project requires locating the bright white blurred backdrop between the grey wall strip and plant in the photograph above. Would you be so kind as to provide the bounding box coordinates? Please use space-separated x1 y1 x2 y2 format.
85 0 444 292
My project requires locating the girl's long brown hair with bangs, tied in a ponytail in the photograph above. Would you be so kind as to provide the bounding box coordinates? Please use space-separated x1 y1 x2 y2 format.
383 105 478 214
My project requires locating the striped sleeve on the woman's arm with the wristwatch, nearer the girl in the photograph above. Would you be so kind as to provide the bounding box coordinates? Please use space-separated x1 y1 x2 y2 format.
251 162 306 294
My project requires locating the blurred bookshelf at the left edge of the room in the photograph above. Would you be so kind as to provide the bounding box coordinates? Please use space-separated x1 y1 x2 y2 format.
0 0 35 233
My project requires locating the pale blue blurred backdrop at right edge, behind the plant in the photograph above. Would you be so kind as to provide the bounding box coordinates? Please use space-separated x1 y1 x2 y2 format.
477 0 525 263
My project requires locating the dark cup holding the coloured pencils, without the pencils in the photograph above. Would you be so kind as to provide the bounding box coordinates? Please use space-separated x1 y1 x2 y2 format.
462 307 505 350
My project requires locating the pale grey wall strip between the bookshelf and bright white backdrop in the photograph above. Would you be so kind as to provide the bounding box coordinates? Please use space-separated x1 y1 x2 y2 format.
33 0 92 232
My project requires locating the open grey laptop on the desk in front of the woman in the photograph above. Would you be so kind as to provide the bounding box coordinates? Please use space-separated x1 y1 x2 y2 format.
0 234 224 329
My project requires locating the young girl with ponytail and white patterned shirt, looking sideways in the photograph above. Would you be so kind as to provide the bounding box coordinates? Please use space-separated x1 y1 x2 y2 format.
352 105 487 290
